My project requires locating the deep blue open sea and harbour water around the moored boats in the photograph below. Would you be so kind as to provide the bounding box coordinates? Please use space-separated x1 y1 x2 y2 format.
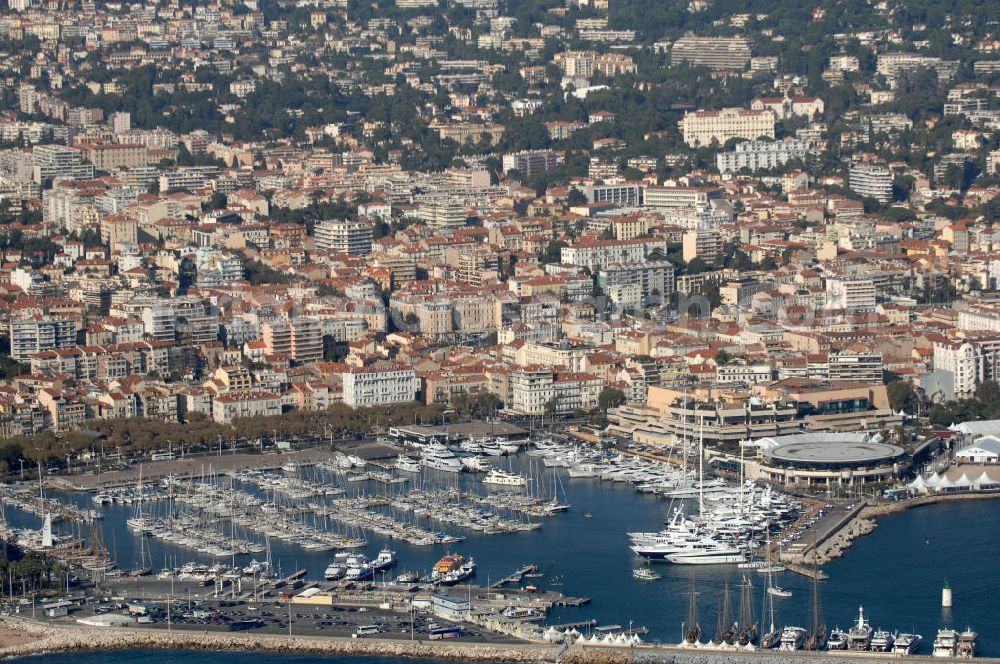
8 461 1000 664
